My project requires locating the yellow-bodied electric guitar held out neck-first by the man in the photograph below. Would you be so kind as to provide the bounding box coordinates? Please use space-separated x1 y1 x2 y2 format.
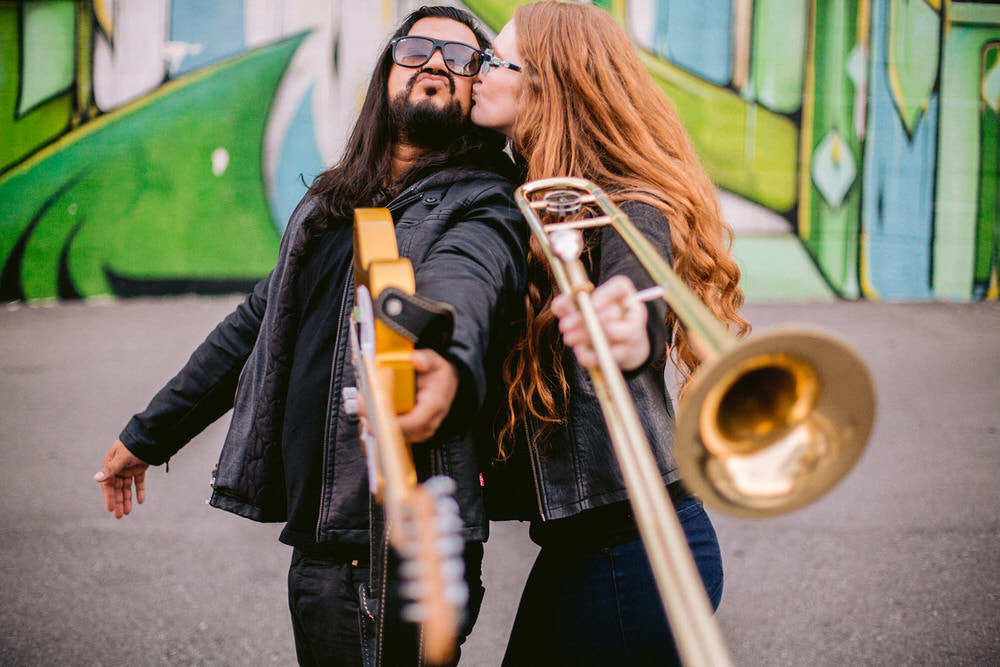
350 208 469 664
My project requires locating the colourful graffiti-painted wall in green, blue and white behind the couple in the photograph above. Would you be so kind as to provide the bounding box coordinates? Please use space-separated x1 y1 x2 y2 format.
0 0 1000 301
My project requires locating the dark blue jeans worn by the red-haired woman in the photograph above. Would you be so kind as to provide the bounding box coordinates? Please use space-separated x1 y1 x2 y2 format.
503 497 722 667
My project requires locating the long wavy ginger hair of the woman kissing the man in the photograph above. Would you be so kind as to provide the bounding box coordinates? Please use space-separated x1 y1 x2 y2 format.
499 2 749 459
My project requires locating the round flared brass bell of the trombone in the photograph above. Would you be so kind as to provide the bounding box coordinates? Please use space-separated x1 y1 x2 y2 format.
674 329 875 517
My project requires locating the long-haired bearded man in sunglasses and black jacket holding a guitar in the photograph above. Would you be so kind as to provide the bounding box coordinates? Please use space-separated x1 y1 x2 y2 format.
95 7 527 665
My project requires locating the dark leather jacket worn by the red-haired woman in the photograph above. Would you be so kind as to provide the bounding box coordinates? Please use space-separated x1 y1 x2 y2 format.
486 202 679 521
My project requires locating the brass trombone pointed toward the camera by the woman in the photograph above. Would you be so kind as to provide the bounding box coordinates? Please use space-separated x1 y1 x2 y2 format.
514 178 875 666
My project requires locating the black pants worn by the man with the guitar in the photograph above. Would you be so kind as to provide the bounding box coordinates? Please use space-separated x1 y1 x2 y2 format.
288 542 485 667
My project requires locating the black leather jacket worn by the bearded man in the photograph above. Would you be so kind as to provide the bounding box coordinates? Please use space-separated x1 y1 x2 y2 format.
121 167 527 544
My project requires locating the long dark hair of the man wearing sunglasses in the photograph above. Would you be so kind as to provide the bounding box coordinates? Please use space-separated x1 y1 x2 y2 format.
309 7 505 224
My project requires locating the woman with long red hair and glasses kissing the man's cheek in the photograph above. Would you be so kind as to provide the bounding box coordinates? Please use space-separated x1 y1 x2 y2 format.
472 2 749 665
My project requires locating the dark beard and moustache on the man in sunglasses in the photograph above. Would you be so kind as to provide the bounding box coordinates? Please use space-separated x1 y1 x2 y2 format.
389 72 468 150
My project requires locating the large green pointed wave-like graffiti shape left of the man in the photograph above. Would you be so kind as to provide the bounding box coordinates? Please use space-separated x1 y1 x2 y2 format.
0 36 303 299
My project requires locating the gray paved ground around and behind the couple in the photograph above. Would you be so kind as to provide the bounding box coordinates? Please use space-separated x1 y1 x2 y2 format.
0 297 1000 665
